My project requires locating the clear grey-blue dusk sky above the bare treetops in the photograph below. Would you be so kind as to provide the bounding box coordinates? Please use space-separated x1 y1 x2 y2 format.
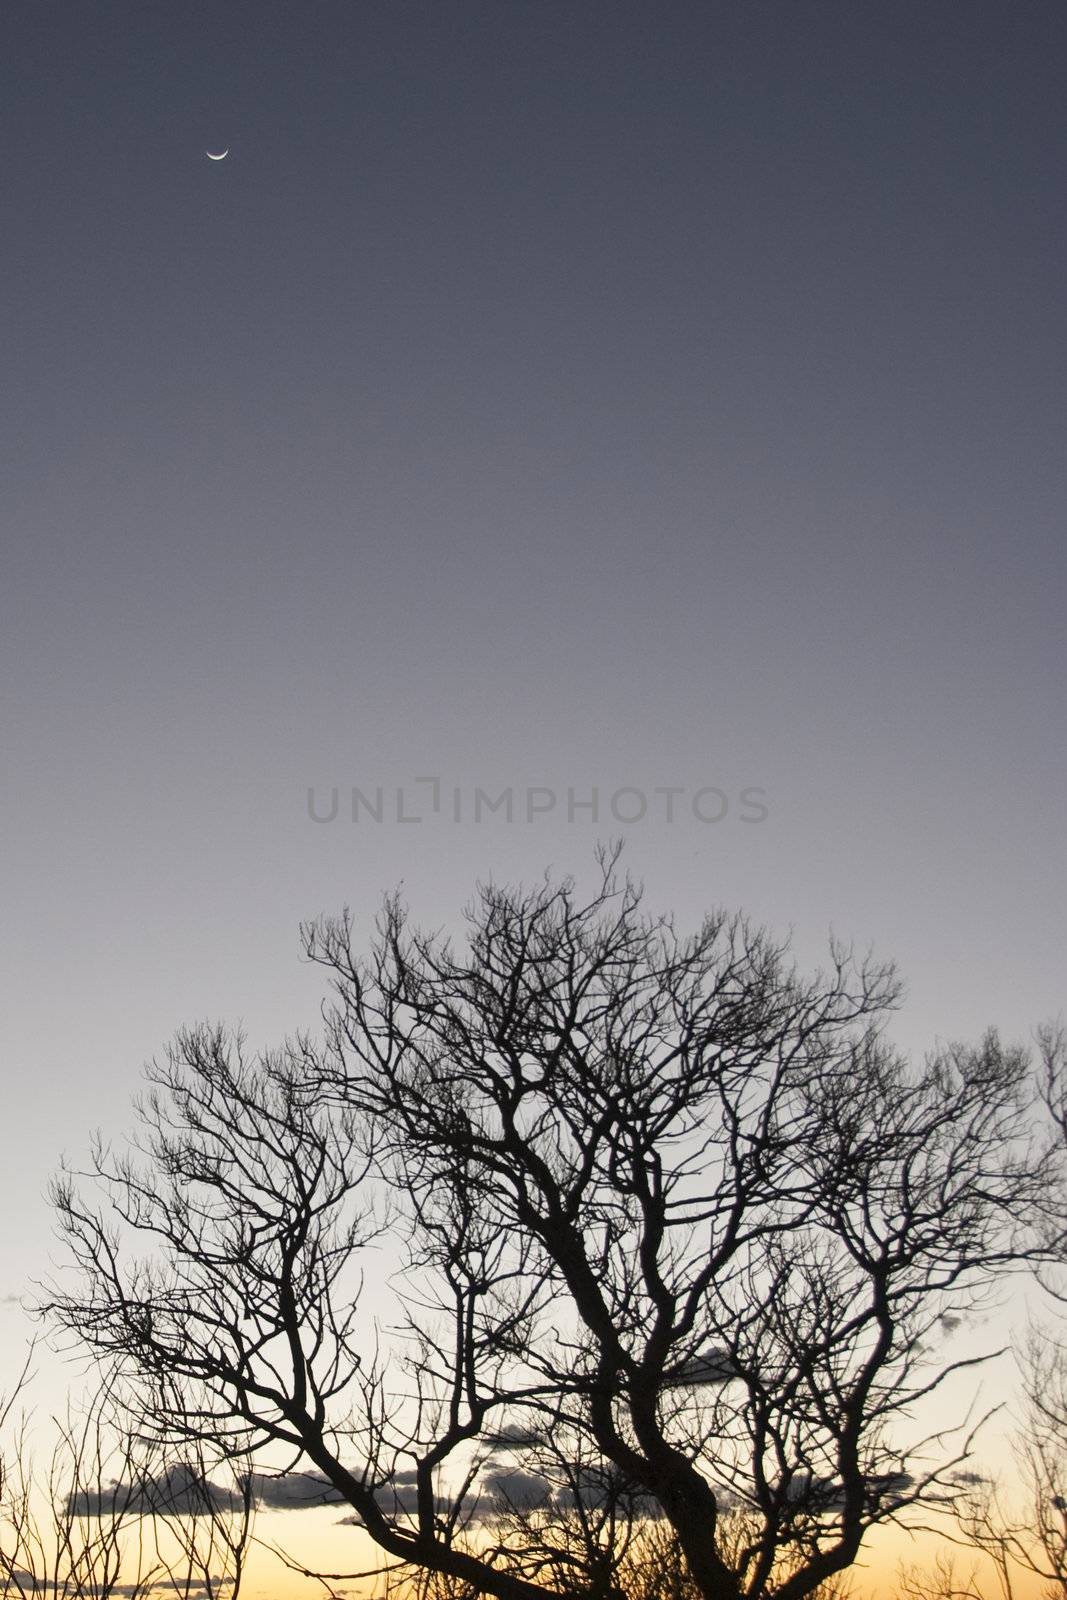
0 0 1067 1389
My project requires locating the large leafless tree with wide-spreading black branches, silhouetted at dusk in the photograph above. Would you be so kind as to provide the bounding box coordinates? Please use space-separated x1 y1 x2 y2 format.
45 853 1054 1600
